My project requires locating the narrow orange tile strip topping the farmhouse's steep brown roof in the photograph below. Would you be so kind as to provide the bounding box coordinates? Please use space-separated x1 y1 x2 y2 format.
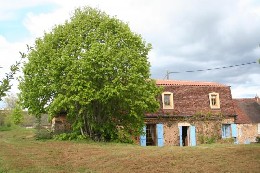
156 80 227 87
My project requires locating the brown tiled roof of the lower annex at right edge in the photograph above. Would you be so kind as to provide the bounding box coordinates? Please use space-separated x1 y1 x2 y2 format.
233 98 260 124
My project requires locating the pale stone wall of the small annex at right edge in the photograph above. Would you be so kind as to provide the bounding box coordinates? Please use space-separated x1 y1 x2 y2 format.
237 123 260 144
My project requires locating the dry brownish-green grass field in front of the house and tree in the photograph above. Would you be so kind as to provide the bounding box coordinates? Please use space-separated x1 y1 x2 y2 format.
0 128 260 173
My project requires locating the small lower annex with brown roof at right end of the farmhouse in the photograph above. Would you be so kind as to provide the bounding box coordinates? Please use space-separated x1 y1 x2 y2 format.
233 96 260 144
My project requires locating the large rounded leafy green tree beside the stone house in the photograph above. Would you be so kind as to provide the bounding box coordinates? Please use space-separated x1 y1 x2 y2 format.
19 7 160 140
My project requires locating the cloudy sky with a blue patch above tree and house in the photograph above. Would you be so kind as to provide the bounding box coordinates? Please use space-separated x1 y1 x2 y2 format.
0 0 260 108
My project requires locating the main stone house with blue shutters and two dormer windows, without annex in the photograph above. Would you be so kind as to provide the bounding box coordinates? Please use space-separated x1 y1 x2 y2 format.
140 80 237 146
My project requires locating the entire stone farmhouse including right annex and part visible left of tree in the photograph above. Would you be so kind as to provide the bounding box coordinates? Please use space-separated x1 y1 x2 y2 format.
52 80 260 146
